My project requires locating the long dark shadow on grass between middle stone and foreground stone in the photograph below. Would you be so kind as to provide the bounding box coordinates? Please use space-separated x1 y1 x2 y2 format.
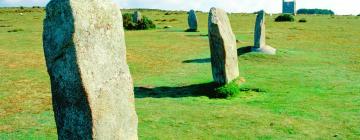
134 82 218 98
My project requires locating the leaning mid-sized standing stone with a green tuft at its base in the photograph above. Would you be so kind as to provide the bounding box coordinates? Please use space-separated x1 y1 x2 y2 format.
209 8 239 85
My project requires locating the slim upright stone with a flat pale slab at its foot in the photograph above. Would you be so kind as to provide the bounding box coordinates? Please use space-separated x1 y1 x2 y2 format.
252 11 276 55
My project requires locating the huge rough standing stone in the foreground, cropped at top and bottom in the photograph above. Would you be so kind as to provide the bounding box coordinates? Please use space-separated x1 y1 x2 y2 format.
43 0 138 140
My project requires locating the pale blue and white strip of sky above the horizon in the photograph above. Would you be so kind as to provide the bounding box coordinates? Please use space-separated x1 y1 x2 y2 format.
0 0 360 15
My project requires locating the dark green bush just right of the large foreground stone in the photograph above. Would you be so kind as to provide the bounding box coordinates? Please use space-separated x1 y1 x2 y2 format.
123 13 156 30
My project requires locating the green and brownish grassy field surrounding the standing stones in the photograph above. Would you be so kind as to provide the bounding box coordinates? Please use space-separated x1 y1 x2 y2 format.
0 9 360 140
